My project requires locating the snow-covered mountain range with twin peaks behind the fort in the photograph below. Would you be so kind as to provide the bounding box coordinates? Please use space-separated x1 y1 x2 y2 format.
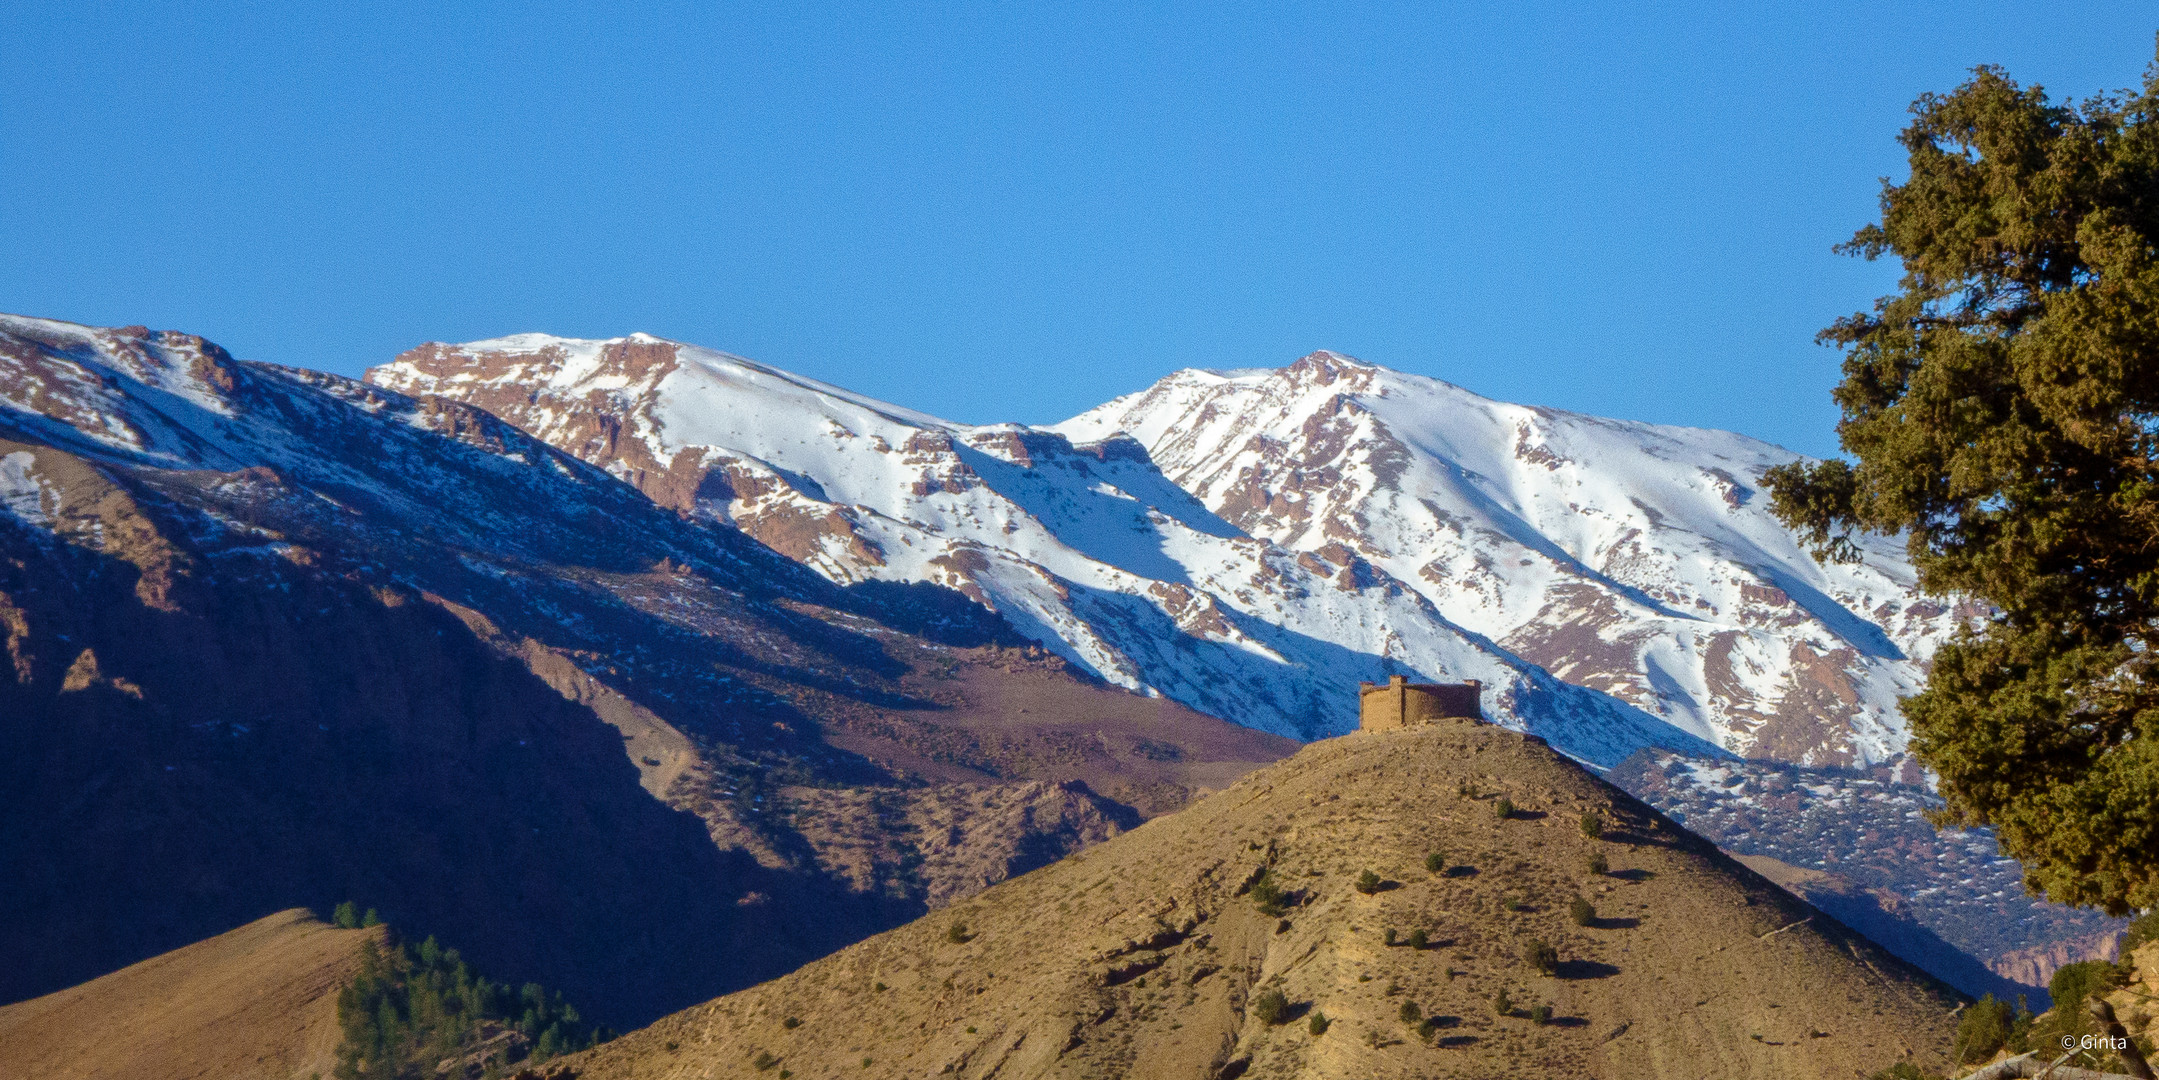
379 335 1956 765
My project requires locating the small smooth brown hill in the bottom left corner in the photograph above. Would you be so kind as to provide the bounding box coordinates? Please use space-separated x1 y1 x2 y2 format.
0 907 382 1080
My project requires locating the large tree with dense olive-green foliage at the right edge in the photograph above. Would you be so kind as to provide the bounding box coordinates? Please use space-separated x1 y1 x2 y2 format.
1766 48 2159 914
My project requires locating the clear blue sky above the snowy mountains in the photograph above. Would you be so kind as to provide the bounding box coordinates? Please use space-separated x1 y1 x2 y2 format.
0 0 2159 454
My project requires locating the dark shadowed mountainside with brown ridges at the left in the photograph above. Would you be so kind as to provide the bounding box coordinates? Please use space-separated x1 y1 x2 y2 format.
0 318 1289 1026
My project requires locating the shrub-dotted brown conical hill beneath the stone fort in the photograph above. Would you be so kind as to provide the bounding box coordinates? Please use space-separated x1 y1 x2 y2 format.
574 724 1956 1080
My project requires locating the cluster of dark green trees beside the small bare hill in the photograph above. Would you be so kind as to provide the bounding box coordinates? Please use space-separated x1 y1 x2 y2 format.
337 924 605 1080
